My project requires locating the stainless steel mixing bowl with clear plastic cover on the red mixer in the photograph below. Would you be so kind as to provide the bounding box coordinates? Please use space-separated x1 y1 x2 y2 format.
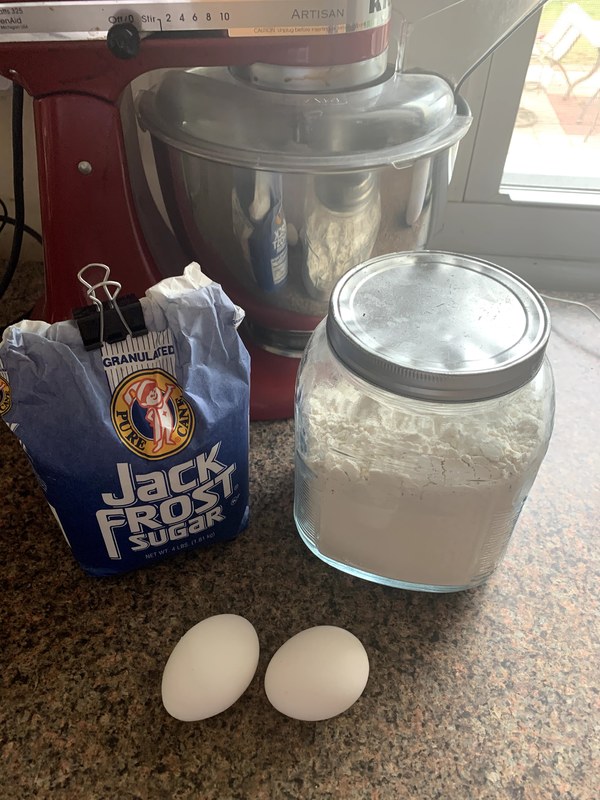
138 67 471 356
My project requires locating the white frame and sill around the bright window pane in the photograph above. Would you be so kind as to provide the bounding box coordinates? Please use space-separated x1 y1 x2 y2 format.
431 9 600 291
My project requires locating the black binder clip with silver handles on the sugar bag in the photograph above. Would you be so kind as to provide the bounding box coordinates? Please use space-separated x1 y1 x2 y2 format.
73 264 148 350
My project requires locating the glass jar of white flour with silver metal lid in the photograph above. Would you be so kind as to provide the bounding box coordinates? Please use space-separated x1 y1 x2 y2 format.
294 252 554 592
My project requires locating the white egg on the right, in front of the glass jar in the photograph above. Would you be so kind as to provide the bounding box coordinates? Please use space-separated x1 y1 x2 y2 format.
265 625 369 722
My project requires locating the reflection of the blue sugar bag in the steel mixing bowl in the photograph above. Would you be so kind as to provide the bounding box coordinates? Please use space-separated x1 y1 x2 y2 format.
232 169 288 291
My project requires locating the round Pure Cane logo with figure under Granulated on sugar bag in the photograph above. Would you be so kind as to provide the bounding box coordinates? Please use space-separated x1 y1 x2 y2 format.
110 369 195 459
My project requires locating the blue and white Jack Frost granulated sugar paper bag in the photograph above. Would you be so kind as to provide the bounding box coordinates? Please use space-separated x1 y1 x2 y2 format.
0 263 250 576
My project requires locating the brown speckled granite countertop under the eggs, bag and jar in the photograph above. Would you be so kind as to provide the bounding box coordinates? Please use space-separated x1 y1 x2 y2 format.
0 270 600 800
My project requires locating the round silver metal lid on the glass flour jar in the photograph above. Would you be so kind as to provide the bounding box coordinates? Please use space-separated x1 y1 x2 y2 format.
326 251 550 402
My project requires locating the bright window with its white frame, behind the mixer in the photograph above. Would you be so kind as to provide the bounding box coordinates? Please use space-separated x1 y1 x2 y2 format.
433 0 600 290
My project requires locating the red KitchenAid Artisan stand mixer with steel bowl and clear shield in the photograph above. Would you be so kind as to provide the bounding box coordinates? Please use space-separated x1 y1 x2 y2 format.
0 0 540 419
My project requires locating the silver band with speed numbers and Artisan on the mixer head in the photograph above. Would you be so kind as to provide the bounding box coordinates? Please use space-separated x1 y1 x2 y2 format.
0 0 391 41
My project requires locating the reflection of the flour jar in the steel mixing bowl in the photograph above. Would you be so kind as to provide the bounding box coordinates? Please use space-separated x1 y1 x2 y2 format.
302 172 381 300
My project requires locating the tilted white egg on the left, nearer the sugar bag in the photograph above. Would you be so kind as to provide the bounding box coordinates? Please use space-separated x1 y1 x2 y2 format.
161 614 259 722
